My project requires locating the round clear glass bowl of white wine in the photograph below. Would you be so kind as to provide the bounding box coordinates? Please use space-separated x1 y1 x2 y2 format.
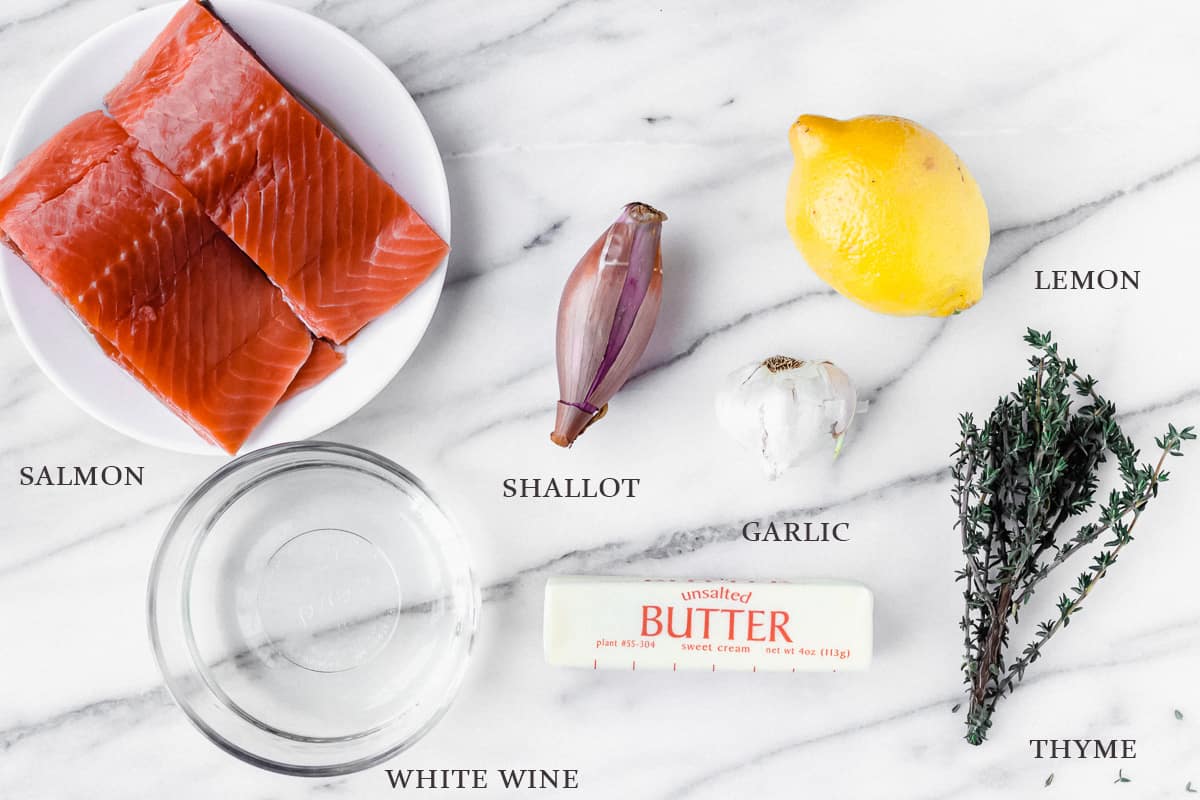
149 441 479 776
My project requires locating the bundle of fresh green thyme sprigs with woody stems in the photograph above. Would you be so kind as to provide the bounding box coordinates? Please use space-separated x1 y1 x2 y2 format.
953 329 1195 745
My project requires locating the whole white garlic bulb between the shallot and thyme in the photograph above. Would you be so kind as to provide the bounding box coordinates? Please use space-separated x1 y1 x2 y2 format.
716 355 866 480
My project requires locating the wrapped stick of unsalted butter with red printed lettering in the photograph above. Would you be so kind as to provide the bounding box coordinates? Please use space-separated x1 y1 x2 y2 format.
544 576 874 672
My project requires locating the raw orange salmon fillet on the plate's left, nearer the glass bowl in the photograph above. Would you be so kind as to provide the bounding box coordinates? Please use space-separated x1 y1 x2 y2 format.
0 112 312 453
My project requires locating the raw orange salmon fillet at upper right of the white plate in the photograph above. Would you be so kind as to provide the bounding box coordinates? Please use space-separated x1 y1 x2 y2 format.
106 0 449 344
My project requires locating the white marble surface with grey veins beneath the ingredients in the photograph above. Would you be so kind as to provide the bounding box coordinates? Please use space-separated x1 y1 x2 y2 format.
0 0 1200 800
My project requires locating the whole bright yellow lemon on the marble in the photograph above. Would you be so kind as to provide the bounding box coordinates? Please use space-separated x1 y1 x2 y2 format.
787 114 990 317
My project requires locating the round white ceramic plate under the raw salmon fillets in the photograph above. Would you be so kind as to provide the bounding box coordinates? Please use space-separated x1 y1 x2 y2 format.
0 0 450 455
